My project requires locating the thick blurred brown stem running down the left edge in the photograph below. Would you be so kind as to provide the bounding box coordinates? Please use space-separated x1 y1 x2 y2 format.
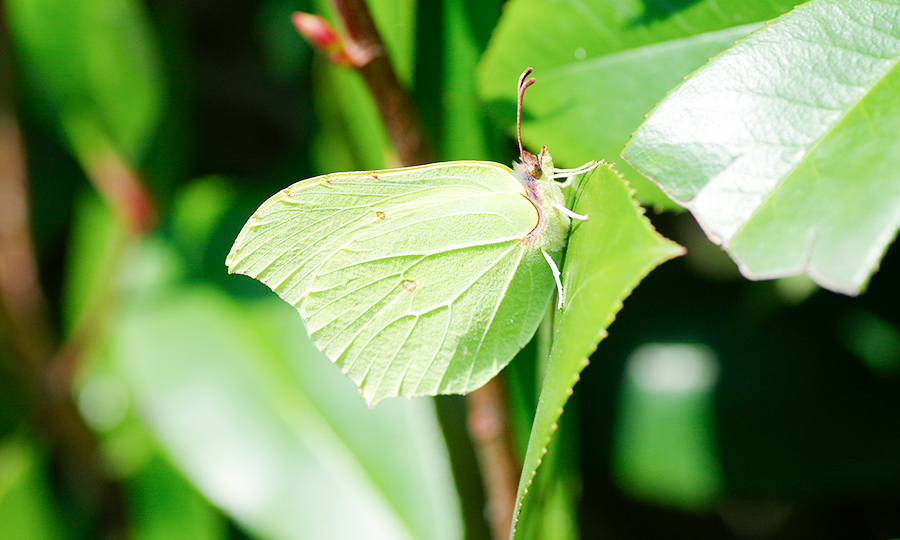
0 105 124 537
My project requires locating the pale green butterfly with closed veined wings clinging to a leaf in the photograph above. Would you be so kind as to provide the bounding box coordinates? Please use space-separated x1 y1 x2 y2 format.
225 68 597 406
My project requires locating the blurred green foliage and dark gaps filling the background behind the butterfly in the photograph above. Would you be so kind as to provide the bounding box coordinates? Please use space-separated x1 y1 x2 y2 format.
0 0 900 539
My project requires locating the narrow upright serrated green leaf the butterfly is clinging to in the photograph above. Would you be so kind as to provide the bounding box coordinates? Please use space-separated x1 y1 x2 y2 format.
513 165 684 536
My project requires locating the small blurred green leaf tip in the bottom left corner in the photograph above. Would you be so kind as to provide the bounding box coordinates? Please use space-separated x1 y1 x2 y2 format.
0 435 63 540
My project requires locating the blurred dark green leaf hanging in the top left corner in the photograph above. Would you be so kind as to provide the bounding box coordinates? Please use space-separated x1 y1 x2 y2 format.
5 0 162 162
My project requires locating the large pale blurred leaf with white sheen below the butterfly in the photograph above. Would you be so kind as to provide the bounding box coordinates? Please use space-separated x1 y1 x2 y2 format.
113 289 462 539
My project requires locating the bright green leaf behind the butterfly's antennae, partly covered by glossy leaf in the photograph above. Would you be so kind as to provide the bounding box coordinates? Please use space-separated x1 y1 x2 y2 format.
478 0 794 207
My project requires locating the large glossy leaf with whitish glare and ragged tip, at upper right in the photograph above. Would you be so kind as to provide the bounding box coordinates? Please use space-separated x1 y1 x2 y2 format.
625 0 900 294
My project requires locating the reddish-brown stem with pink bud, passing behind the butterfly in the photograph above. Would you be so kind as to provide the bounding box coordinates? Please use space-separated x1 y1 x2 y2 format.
310 0 520 540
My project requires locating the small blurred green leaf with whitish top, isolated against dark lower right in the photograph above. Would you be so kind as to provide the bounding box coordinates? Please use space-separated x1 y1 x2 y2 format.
613 344 723 511
